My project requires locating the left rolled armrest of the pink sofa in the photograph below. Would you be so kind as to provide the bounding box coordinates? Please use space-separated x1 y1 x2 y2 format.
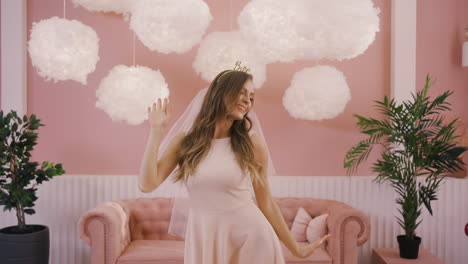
78 202 131 264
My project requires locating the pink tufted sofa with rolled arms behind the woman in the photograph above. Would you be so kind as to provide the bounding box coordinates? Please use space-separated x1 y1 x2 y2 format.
78 197 370 264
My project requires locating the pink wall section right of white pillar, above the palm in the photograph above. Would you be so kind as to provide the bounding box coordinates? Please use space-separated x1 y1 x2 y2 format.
416 0 468 168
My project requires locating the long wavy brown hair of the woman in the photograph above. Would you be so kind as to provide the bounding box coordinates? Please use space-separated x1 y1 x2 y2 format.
173 70 266 184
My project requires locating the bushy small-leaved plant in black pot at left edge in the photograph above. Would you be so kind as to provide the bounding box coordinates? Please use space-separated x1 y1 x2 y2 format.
0 111 65 264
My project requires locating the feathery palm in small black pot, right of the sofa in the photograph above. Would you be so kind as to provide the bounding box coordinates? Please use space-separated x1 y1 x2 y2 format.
344 76 468 259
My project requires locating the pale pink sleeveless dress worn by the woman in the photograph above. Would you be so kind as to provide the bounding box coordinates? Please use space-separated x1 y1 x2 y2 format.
184 137 285 264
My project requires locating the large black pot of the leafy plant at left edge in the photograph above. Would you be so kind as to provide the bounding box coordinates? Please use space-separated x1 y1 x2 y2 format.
0 225 50 264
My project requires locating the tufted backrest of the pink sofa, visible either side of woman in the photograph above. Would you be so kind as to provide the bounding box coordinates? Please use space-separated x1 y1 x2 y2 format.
118 197 350 240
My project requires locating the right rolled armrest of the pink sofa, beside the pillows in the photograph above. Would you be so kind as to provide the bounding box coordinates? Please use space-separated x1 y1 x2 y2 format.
327 202 370 264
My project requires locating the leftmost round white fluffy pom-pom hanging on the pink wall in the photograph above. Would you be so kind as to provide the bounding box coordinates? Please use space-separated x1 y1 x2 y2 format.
28 17 99 84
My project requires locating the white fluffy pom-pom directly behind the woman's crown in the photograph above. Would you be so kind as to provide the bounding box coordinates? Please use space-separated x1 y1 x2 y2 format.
192 31 266 89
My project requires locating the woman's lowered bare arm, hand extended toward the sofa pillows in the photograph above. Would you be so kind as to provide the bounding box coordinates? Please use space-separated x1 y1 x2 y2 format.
252 134 330 258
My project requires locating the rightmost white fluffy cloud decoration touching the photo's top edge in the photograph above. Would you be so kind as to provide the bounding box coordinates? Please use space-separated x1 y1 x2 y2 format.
298 0 380 60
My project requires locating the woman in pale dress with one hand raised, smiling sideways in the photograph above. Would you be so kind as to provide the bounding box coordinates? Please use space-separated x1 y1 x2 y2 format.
138 70 330 264
